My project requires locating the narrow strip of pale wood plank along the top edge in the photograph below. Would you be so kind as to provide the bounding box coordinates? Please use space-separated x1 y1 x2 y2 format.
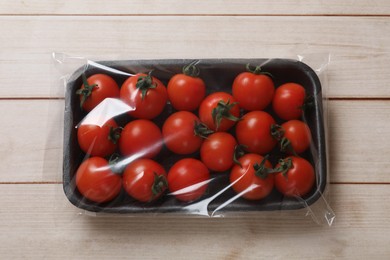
0 0 390 15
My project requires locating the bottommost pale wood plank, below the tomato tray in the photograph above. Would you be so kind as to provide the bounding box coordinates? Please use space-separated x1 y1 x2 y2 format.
0 185 390 259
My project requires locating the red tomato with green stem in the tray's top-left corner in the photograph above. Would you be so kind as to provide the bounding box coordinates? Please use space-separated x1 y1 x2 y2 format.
76 74 119 111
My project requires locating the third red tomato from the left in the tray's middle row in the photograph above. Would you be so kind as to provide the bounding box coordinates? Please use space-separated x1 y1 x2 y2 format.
162 111 203 154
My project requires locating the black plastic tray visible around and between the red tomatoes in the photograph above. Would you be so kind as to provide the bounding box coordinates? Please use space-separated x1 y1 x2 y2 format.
63 59 327 213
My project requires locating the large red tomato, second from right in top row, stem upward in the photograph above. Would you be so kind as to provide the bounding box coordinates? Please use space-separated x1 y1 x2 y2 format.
232 64 275 111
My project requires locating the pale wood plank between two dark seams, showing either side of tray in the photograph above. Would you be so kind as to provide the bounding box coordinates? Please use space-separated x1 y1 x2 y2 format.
0 100 390 183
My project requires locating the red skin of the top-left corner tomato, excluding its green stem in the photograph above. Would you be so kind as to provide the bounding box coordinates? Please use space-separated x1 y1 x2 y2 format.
76 74 120 112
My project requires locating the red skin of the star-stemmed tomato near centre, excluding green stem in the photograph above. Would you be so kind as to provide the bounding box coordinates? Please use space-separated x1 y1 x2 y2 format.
199 92 240 132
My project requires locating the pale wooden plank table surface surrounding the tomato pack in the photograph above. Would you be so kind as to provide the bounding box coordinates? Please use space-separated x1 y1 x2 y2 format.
0 0 390 259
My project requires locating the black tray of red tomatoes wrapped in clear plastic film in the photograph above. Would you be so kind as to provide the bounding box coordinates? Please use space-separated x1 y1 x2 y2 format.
63 59 327 216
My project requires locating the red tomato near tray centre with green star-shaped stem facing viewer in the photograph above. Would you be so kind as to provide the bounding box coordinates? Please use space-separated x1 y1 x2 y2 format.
199 92 240 132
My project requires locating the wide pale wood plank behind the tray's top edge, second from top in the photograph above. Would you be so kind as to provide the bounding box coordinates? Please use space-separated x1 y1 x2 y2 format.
0 16 390 97
